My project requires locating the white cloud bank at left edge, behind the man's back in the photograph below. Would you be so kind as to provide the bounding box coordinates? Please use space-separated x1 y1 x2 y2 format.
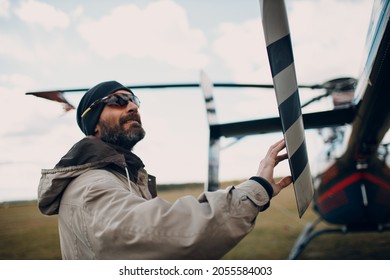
0 74 81 201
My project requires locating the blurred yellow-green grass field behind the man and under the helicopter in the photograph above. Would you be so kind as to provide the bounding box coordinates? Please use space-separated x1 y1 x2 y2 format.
0 184 390 260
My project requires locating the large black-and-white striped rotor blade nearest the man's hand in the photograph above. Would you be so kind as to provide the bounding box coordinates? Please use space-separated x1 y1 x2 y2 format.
260 0 313 217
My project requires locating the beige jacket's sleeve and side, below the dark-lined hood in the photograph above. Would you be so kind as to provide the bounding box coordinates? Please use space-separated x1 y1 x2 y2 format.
78 171 272 259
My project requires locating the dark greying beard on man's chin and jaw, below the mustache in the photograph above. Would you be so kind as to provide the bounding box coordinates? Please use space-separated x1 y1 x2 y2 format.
99 118 145 151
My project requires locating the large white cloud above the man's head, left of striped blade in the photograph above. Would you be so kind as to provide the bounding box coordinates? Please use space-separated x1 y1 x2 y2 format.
78 0 208 69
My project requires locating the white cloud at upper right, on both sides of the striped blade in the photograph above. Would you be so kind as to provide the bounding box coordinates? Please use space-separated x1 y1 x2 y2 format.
213 0 371 83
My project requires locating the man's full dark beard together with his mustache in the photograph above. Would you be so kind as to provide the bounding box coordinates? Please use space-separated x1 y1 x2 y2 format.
99 112 145 150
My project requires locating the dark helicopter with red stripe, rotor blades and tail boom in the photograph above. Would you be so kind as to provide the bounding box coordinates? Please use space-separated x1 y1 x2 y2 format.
26 0 390 259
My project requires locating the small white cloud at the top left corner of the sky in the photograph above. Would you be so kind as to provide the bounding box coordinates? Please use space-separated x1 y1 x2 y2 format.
15 0 70 31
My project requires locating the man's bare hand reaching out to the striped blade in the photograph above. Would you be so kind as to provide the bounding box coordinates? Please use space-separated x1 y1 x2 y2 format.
257 139 292 196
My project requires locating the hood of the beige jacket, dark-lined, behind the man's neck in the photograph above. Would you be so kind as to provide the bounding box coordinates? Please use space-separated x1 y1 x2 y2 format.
38 136 144 215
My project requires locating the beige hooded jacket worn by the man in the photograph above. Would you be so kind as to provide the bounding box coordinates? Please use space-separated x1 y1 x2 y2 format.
38 137 269 259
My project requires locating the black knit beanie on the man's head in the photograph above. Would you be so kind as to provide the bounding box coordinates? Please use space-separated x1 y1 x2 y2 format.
77 81 131 136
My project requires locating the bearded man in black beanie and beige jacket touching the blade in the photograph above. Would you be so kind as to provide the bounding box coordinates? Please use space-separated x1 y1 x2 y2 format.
38 81 291 259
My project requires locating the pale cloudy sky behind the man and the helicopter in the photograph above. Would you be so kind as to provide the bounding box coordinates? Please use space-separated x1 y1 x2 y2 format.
0 0 372 202
